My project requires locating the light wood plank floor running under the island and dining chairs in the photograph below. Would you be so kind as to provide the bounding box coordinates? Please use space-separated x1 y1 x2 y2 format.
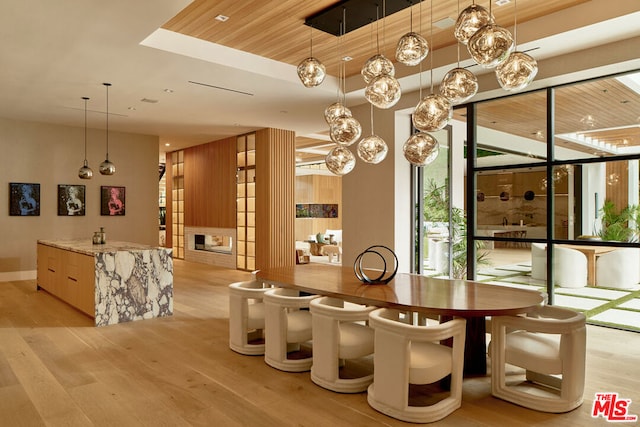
0 260 640 427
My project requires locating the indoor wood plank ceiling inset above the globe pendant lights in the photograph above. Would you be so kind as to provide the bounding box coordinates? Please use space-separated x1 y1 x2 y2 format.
163 0 587 76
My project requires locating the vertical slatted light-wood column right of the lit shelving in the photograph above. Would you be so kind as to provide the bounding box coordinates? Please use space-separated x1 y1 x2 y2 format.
256 129 295 269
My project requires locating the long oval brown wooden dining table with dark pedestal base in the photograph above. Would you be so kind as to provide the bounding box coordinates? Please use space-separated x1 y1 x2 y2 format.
256 264 544 375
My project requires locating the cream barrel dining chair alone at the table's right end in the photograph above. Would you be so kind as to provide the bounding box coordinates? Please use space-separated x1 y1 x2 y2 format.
489 305 586 413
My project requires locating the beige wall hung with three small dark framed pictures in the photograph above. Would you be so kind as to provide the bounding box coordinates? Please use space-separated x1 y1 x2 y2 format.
0 118 159 281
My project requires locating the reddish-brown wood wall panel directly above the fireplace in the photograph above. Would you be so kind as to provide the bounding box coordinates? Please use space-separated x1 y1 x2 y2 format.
184 137 236 228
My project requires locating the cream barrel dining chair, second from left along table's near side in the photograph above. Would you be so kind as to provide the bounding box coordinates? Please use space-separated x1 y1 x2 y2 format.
264 288 318 372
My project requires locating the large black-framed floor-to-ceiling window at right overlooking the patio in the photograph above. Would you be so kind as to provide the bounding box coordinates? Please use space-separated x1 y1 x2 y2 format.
467 69 640 330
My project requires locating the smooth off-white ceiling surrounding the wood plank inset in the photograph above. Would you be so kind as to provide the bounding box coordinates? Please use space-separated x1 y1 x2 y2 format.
0 0 640 154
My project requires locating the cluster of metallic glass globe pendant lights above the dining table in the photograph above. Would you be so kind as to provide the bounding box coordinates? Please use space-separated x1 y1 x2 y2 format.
298 0 538 175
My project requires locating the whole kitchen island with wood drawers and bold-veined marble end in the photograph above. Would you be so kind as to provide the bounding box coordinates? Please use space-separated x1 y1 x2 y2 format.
37 240 173 326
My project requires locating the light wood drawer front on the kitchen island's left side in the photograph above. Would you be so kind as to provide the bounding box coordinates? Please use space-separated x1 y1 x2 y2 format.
37 244 95 317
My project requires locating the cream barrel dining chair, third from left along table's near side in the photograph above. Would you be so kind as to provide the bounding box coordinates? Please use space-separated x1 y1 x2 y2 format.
309 297 376 393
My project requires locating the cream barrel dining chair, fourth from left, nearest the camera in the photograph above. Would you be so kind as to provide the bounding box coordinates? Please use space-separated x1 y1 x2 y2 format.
367 308 466 423
